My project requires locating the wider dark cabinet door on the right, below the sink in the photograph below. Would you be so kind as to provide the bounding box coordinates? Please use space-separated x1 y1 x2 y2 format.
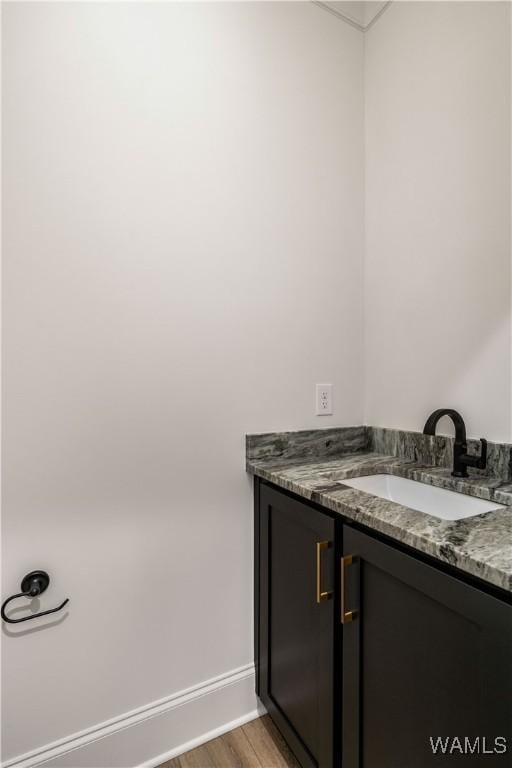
340 526 512 768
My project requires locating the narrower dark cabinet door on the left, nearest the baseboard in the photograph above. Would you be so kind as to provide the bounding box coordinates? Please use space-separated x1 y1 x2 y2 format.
257 484 334 768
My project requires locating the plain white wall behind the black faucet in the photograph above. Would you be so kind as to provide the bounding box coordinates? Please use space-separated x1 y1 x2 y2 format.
365 2 512 440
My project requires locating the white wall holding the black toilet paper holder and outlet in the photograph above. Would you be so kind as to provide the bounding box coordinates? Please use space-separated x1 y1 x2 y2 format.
2 2 363 765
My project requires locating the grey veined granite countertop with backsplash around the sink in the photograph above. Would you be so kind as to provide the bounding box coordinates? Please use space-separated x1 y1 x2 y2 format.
246 427 512 592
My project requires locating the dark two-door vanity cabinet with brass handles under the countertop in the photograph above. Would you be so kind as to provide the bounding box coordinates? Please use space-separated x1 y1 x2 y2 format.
255 480 512 768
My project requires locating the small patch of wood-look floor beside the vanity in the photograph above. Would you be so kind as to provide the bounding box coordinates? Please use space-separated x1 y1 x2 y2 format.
159 715 300 768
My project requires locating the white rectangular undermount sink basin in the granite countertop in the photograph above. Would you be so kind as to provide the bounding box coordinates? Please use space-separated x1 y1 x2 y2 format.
339 475 503 520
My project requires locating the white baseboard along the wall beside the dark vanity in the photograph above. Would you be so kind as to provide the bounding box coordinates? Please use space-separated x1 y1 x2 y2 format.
2 664 264 768
